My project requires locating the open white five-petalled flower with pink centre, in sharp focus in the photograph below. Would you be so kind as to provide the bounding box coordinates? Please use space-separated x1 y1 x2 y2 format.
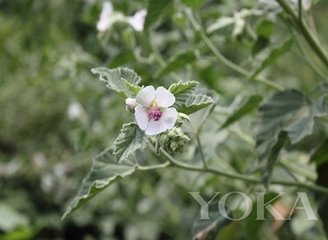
134 86 178 135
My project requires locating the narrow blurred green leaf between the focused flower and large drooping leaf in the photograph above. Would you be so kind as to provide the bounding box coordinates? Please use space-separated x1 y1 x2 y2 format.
220 95 262 129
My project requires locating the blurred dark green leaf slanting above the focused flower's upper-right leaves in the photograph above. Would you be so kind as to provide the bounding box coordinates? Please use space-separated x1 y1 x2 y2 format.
156 51 196 77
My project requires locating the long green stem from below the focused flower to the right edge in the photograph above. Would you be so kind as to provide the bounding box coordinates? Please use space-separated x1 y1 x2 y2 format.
160 148 328 195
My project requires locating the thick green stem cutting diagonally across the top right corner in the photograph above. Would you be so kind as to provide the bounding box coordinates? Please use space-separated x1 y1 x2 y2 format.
277 0 328 67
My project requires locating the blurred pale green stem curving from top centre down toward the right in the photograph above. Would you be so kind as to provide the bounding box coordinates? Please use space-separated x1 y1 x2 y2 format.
185 10 283 90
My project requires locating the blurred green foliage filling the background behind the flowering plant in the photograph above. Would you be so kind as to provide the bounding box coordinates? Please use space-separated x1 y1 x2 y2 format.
0 0 328 240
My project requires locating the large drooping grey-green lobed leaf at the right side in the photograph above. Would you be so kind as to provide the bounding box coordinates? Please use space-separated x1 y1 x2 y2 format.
256 90 327 185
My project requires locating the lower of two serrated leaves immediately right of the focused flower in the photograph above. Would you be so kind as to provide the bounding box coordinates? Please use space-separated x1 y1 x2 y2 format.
176 94 214 114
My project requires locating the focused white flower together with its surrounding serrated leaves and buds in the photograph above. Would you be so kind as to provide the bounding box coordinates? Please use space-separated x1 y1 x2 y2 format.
63 68 213 217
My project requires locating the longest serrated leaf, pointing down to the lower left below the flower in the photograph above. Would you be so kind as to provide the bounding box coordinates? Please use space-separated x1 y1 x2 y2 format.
62 148 137 219
